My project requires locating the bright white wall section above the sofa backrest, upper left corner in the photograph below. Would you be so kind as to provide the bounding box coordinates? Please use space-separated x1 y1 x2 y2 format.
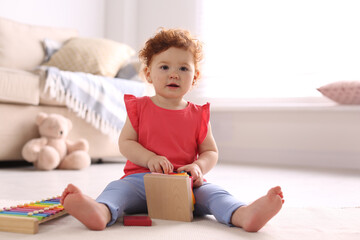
0 0 106 37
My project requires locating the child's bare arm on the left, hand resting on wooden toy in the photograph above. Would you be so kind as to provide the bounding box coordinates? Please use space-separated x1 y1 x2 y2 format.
119 118 174 173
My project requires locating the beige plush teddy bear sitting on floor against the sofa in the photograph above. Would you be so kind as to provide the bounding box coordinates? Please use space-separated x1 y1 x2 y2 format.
22 112 91 170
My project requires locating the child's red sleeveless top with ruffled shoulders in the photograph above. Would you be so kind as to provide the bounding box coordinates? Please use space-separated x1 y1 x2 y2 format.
124 95 210 177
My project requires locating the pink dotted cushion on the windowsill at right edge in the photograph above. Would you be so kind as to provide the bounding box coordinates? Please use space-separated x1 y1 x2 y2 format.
317 81 360 104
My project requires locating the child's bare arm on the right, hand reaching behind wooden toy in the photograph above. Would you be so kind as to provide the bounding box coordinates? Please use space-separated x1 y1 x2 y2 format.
177 123 218 187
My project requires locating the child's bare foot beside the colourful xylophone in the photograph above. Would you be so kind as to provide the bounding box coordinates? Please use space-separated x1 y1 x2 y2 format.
60 184 111 230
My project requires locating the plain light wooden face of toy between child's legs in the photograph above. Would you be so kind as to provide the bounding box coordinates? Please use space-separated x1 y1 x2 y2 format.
144 173 193 222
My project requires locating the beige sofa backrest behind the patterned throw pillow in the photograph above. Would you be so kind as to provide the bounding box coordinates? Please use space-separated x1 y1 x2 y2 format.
0 18 77 70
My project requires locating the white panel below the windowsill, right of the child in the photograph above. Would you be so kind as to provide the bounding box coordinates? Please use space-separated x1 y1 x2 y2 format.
211 105 360 170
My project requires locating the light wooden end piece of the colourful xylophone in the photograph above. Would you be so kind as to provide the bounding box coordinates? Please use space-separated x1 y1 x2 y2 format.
0 215 39 234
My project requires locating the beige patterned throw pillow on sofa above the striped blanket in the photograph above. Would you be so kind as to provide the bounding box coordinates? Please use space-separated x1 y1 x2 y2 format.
44 38 135 77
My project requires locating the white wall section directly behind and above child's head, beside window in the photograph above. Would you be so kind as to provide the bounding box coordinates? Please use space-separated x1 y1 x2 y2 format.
106 0 201 50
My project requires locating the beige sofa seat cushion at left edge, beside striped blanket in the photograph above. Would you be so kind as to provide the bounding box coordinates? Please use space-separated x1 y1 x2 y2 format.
0 68 40 105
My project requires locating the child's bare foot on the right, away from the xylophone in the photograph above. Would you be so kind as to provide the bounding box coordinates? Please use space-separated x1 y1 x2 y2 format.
231 187 284 232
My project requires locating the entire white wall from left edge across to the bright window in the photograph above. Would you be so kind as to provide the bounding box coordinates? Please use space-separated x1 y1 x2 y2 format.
0 0 200 50
